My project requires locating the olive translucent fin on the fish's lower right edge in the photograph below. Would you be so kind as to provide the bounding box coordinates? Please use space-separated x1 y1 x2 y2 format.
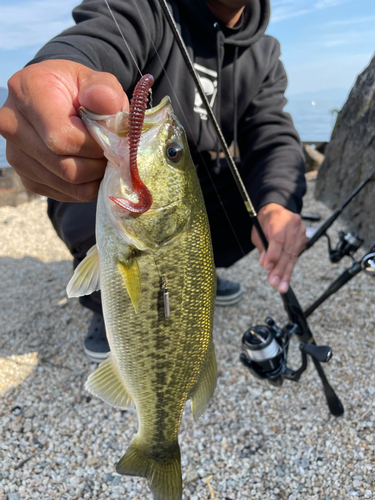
190 343 217 421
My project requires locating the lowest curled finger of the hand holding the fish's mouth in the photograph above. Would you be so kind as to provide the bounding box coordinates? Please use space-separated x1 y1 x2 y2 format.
7 145 100 202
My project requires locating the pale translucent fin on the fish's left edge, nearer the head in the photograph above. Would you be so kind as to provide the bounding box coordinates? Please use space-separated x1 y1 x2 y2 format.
66 245 100 298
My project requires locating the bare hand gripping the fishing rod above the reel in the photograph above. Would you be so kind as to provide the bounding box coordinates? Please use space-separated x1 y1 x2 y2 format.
251 203 308 293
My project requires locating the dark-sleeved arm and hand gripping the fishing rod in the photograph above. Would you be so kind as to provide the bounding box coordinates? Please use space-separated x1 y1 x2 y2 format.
239 37 307 293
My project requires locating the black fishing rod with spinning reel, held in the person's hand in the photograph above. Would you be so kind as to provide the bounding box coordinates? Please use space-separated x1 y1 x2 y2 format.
158 0 344 416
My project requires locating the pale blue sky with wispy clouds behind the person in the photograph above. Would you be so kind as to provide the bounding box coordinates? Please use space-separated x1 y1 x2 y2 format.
0 0 375 95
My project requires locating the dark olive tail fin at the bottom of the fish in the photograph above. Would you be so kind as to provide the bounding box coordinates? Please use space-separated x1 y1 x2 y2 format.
116 437 182 500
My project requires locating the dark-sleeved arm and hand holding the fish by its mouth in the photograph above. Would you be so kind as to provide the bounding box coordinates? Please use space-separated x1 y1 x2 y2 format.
0 0 161 202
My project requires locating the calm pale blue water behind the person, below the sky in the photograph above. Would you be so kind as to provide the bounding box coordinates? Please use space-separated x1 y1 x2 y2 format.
0 89 346 168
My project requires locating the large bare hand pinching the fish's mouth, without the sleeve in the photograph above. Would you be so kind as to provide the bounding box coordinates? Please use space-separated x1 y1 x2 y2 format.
0 60 129 202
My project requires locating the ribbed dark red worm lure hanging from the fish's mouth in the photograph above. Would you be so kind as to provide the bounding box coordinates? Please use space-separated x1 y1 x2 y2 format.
109 75 154 214
